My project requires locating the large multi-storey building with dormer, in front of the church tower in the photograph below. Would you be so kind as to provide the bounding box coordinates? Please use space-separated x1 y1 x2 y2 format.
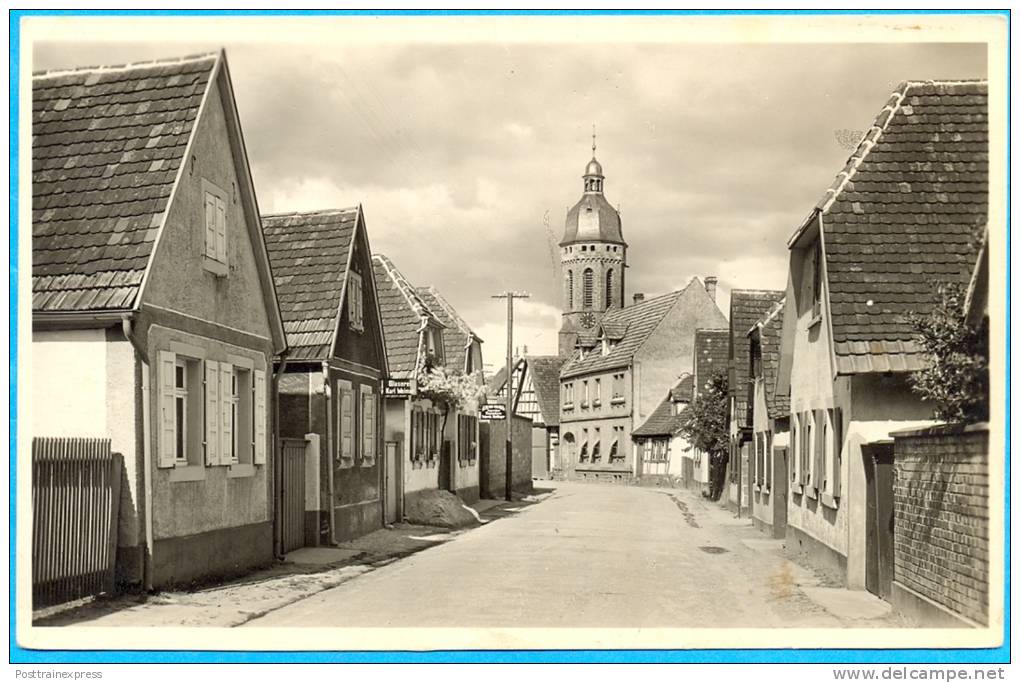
560 278 726 482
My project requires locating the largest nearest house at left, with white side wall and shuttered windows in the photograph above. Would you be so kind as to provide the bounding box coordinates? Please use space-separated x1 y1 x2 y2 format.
31 52 286 588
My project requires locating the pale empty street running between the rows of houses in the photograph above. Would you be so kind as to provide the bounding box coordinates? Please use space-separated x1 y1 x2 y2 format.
246 483 895 628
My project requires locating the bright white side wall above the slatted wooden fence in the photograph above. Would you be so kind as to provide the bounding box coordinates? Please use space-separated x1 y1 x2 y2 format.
31 329 108 437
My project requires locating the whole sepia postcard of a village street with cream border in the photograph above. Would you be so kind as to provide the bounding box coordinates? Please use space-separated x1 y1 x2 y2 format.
11 13 1009 651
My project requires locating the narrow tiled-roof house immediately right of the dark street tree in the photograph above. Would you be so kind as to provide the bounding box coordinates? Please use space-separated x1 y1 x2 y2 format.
727 290 782 513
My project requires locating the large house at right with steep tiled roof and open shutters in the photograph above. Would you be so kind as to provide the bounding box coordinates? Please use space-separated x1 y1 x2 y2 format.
777 81 988 588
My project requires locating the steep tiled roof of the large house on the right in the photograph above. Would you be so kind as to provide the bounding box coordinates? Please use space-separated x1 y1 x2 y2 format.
817 82 988 372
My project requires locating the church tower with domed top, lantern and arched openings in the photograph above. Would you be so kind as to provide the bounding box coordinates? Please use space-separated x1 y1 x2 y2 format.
559 130 627 357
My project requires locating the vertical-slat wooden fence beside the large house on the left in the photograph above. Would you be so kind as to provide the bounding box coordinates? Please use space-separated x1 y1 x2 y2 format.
32 438 123 610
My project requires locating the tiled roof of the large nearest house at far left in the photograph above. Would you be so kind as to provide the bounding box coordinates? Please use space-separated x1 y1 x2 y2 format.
32 55 217 311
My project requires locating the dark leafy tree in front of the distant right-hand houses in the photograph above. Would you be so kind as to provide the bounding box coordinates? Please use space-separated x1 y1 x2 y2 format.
678 371 729 501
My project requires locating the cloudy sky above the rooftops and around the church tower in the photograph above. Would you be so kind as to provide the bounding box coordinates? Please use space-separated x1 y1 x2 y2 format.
33 19 986 365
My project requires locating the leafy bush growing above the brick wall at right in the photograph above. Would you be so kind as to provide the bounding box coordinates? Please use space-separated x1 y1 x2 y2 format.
907 282 988 422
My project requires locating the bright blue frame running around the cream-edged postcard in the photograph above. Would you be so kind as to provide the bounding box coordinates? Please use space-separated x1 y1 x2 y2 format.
8 9 1012 665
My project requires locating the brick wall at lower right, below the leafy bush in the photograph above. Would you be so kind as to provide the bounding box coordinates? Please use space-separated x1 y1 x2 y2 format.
893 426 988 624
